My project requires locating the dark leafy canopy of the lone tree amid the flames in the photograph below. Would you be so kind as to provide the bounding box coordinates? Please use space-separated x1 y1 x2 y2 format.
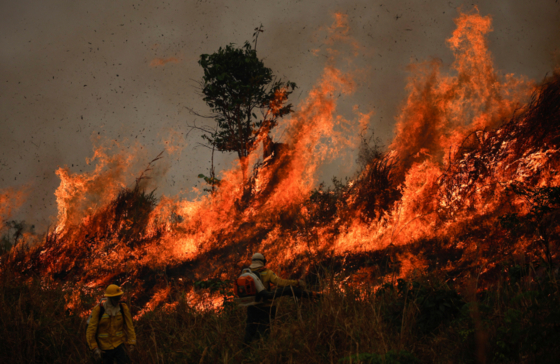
198 36 297 181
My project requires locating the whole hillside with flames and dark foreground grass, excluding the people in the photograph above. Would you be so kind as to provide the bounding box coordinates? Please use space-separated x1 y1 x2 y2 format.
0 9 560 363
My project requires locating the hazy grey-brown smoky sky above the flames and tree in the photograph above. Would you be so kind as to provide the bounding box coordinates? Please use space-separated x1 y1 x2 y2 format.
0 0 560 229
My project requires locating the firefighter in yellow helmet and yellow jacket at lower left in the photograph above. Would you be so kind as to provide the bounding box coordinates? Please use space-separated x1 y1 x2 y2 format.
86 284 136 364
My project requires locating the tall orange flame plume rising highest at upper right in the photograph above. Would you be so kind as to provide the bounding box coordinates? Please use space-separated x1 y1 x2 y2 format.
390 11 534 175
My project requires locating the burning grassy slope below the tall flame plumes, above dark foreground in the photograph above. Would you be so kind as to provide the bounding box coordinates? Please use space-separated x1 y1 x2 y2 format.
2 69 560 324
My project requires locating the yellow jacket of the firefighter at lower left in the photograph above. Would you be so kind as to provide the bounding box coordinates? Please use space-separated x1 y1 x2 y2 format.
86 303 136 350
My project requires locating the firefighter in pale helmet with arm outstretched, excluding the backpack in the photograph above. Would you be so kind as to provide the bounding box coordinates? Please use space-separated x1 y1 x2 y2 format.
243 253 305 344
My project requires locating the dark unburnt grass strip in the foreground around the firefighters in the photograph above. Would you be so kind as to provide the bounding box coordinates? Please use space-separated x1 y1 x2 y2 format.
0 261 560 364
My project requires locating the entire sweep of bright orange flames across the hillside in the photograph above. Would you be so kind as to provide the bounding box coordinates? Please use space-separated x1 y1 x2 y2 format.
5 9 560 315
